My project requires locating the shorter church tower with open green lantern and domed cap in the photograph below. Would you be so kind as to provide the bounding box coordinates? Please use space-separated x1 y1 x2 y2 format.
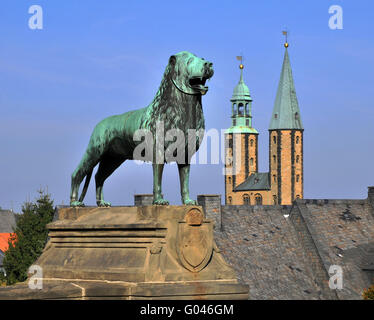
225 64 258 204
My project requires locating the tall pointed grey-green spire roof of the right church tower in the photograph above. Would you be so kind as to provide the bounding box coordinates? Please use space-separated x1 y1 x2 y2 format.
269 42 303 130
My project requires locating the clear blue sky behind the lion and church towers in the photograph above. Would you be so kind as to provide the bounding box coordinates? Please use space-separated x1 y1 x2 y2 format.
0 0 374 211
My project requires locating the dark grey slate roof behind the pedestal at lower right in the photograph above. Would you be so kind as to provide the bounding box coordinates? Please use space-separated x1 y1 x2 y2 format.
198 187 374 299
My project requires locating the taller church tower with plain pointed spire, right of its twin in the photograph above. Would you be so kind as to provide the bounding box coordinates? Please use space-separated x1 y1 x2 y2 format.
269 42 304 205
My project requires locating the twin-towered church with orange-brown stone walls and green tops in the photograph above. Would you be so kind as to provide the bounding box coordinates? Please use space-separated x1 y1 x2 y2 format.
225 43 304 205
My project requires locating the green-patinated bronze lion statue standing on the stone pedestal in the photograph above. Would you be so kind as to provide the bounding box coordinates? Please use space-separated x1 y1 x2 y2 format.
70 51 214 207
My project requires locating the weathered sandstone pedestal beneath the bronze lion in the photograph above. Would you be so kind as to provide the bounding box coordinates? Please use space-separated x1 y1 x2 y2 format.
0 206 249 299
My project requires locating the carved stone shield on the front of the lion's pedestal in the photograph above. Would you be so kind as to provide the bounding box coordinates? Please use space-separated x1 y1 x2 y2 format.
177 208 213 272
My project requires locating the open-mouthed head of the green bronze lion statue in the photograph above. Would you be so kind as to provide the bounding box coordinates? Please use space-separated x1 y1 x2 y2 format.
169 51 214 95
